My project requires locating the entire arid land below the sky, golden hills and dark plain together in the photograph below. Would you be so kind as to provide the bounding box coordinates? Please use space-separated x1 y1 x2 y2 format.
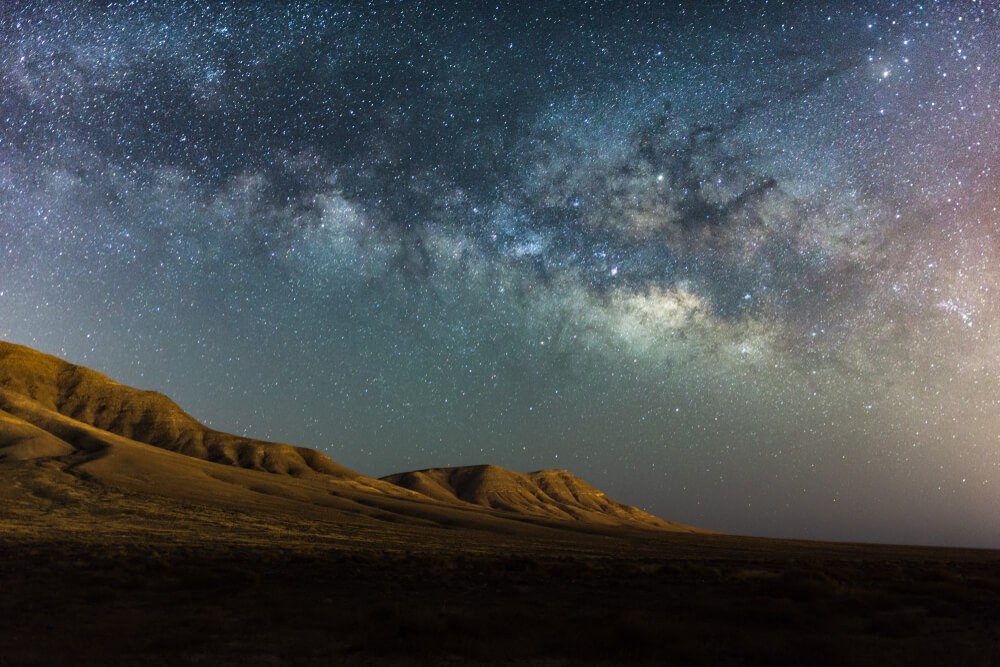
0 343 1000 667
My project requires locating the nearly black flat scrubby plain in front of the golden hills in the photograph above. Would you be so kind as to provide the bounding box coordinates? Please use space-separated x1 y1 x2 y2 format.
0 526 1000 667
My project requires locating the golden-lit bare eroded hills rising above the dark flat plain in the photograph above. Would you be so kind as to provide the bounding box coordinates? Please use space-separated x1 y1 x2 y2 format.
0 342 704 539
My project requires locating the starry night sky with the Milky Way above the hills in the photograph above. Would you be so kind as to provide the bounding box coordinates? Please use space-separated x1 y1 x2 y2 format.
0 0 1000 547
